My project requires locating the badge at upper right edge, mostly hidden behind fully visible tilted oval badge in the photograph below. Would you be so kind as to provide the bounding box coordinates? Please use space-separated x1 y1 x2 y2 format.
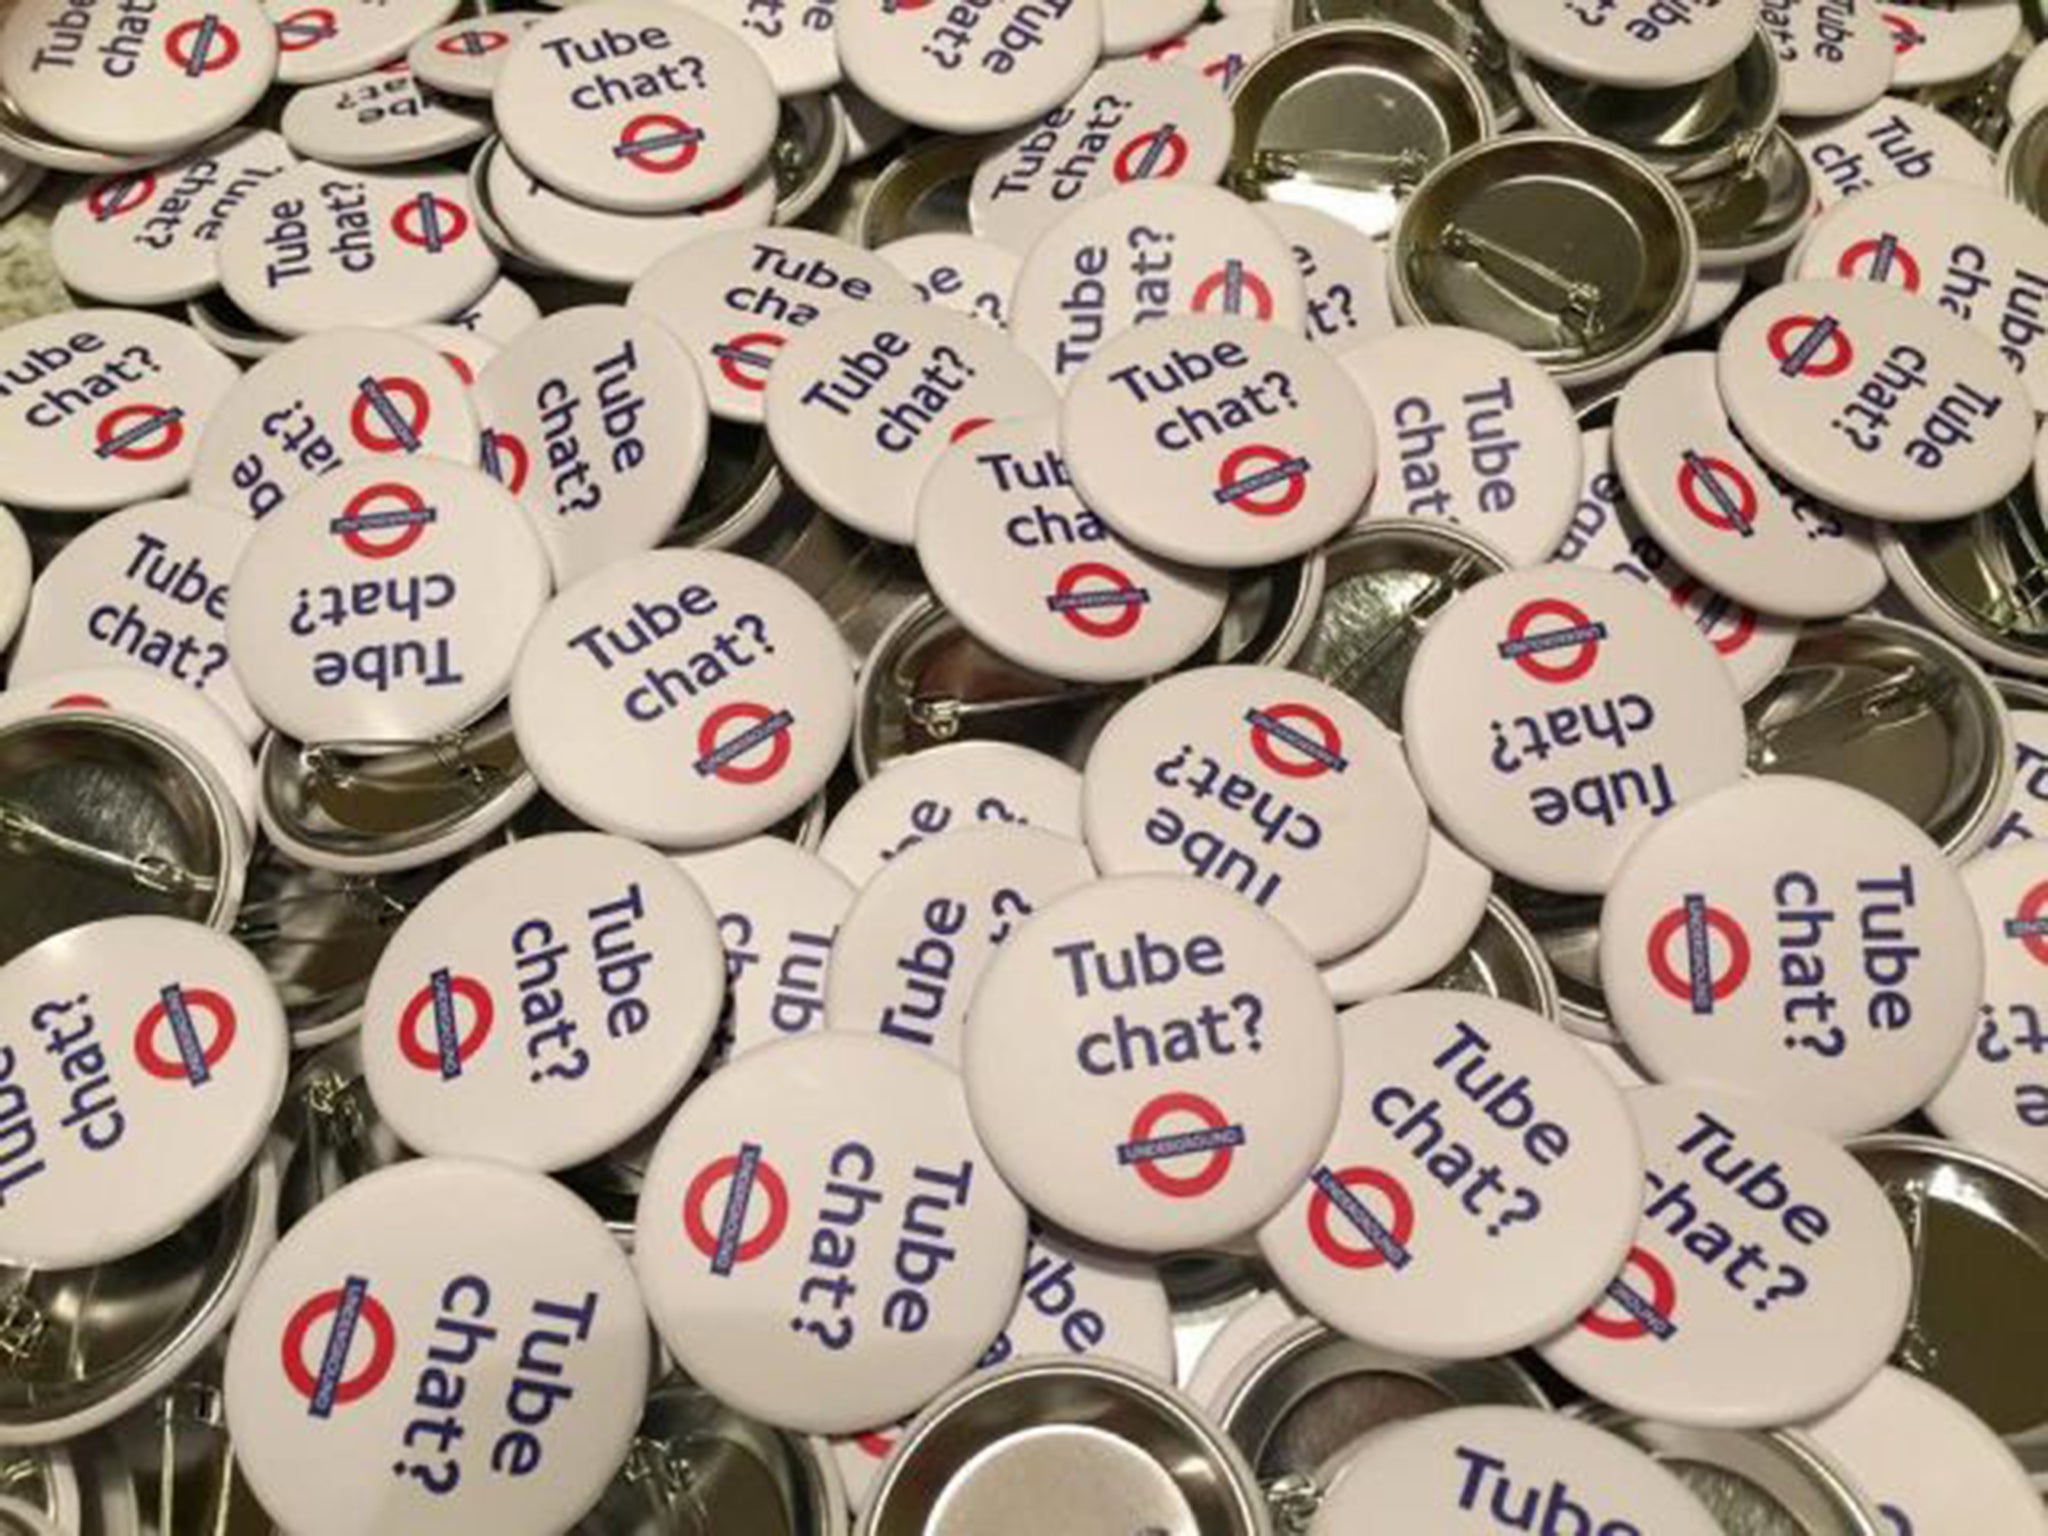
1798 182 2048 412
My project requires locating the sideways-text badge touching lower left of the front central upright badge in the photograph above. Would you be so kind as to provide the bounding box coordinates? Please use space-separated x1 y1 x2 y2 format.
633 1030 1024 1434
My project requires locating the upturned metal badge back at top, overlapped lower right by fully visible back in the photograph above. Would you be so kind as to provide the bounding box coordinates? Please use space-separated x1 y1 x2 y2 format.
1225 20 1493 238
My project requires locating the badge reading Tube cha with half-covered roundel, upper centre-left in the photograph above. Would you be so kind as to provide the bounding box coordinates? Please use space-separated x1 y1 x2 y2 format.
627 229 915 422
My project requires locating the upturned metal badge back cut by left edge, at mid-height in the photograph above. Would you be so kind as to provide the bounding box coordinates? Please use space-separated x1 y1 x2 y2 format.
0 709 248 963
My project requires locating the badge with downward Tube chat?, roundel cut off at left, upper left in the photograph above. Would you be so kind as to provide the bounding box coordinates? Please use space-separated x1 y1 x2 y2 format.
475 305 711 586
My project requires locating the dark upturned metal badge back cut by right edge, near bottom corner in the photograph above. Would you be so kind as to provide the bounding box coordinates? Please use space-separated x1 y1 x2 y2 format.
1849 1135 2048 1475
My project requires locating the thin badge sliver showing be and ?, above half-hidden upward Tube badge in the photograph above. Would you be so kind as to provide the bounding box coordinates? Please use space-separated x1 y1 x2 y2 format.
817 741 1081 889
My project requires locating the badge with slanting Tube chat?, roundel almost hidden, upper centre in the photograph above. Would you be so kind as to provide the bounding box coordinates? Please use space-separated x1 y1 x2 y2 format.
766 303 1057 545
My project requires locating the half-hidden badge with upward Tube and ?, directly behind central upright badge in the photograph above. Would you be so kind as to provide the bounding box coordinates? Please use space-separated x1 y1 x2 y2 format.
825 827 1096 1067
